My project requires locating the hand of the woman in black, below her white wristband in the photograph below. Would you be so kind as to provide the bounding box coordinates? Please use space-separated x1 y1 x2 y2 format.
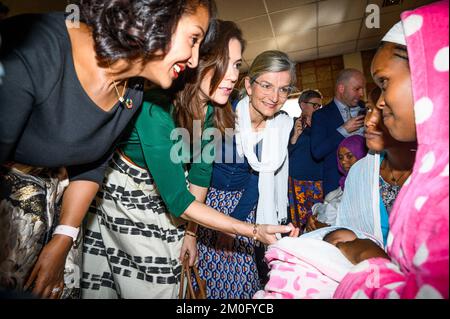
24 235 72 299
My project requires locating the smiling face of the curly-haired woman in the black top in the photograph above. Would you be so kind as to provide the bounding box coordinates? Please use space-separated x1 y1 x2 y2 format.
140 6 209 88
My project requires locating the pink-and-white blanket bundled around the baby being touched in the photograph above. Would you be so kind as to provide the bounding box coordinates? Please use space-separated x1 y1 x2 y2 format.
254 226 383 299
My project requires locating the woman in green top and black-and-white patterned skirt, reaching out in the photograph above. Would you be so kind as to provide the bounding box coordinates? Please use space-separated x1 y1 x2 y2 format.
82 21 298 298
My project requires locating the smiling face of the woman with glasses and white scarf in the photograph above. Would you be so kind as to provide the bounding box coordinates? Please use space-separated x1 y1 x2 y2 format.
245 71 291 119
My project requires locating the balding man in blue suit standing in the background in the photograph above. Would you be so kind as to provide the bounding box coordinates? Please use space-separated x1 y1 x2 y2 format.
311 69 366 195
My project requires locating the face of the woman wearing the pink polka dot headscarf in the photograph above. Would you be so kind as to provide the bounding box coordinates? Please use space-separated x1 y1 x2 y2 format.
371 43 416 142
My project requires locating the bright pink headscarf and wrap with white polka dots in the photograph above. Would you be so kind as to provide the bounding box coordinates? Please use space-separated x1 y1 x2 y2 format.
334 0 449 298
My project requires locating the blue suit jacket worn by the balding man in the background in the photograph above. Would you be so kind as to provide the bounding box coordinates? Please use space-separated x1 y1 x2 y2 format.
311 101 344 195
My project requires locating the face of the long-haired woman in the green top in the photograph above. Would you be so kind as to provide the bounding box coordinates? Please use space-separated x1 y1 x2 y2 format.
200 39 242 105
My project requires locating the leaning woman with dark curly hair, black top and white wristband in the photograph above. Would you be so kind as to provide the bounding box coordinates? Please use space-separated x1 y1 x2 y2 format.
0 0 215 298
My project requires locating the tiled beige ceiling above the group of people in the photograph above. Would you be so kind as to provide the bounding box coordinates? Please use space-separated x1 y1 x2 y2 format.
216 0 434 69
